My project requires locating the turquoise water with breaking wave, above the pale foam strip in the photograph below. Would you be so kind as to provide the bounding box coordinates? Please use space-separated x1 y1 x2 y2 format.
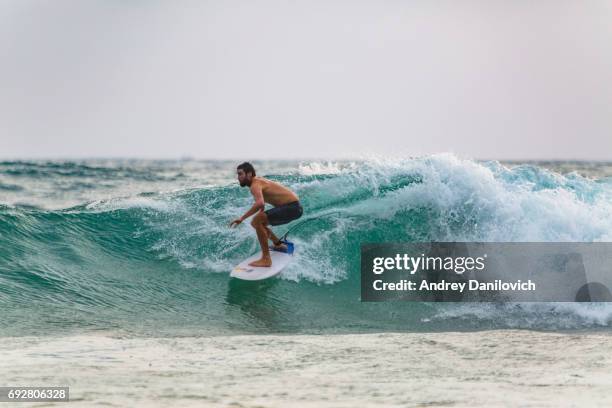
0 154 612 336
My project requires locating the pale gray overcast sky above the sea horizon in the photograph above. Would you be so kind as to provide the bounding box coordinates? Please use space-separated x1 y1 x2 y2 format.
0 0 612 159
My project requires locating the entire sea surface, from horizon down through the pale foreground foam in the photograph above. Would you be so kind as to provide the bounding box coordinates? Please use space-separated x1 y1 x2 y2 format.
0 154 612 408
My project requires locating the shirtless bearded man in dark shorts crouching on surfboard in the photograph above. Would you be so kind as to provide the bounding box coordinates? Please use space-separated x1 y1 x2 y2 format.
230 162 302 266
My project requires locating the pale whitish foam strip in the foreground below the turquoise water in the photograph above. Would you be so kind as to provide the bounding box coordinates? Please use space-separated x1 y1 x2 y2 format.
0 330 612 408
